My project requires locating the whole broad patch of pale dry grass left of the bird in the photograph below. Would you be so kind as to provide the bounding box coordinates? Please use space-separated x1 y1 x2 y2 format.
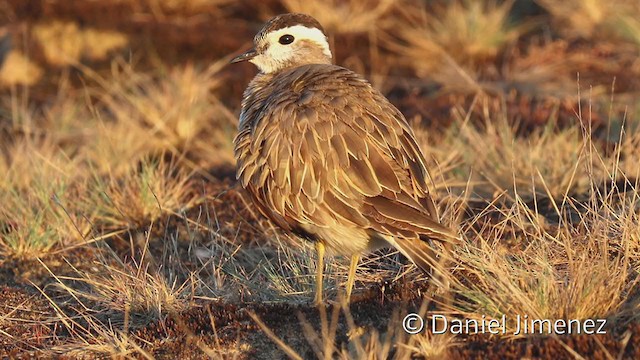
0 60 232 257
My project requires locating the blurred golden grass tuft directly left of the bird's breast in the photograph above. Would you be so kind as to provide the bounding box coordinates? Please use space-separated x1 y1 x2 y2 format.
87 62 236 174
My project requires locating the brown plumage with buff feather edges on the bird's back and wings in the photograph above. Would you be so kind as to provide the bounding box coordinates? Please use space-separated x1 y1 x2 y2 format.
235 65 455 248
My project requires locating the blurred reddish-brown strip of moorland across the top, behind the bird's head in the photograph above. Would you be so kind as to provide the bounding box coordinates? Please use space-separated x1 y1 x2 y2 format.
0 0 640 125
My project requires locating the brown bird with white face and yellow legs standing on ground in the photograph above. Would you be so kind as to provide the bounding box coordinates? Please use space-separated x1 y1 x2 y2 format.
230 13 459 304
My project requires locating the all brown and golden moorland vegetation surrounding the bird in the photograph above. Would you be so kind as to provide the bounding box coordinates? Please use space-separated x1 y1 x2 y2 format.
0 0 640 359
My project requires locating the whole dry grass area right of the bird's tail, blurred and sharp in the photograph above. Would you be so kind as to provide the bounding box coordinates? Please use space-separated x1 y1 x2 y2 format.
416 95 640 338
